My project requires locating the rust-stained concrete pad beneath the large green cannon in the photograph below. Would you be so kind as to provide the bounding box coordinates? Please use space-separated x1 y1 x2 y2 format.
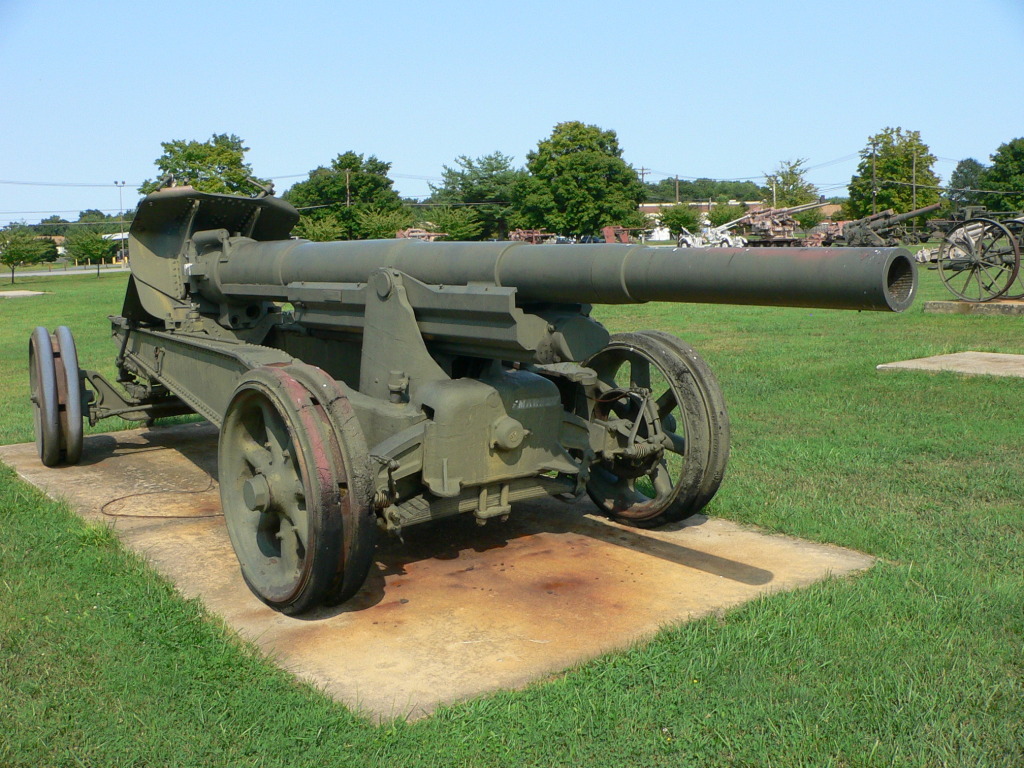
0 424 873 719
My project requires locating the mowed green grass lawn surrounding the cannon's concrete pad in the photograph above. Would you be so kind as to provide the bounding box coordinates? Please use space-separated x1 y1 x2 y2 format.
0 270 1024 766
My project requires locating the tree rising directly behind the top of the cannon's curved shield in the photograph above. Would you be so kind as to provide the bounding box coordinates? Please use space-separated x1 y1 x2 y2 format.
138 133 269 195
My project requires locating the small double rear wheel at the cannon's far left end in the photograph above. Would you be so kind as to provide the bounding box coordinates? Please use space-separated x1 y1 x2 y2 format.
29 326 83 467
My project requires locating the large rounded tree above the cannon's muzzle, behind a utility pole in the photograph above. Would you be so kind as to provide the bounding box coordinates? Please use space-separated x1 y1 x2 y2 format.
848 128 939 218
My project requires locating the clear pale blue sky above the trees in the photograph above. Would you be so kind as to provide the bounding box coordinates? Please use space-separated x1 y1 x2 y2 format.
0 0 1024 225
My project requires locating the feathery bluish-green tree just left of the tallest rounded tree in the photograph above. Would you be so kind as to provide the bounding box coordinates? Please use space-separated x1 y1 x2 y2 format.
430 152 526 240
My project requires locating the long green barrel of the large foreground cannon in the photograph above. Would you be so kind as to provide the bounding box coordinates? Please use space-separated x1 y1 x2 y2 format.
211 240 918 311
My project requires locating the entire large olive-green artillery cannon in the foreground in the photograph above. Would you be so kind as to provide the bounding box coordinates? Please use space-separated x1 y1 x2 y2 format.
30 187 916 613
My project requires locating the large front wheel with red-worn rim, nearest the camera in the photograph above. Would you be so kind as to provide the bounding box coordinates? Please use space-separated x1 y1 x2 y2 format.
218 365 376 614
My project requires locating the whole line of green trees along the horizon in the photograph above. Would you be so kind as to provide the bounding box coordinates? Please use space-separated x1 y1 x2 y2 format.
0 121 1024 280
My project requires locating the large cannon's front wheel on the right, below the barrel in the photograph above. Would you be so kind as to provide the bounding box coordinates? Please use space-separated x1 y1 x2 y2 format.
586 331 729 527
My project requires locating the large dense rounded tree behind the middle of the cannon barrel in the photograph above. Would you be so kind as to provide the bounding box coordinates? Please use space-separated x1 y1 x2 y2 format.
515 122 647 234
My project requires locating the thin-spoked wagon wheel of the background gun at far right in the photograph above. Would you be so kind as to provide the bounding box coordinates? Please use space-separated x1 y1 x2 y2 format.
937 219 1020 302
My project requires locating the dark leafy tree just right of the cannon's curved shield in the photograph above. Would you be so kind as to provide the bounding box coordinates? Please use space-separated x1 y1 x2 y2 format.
284 152 411 240
